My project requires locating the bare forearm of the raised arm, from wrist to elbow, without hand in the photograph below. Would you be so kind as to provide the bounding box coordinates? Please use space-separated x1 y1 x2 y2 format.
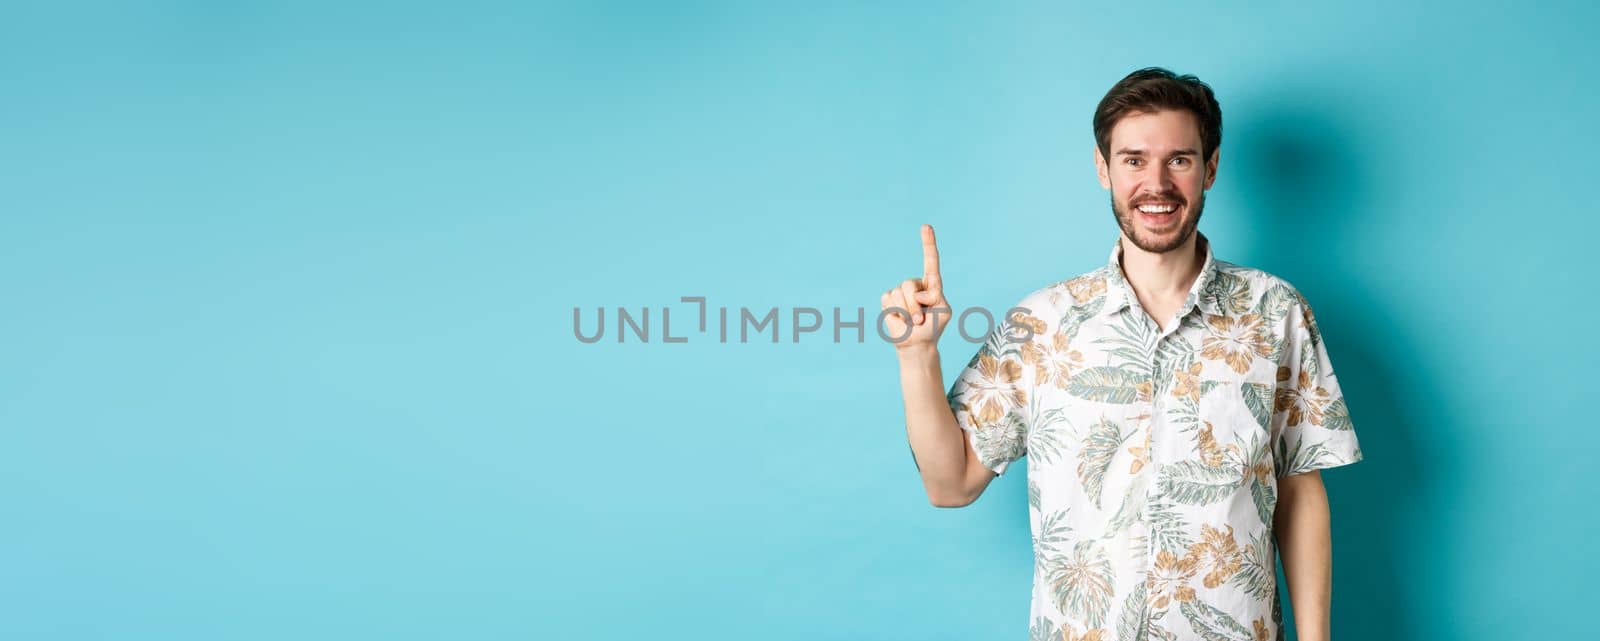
899 347 966 502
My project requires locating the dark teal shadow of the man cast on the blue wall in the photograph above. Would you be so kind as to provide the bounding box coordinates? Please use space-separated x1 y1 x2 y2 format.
1222 96 1440 641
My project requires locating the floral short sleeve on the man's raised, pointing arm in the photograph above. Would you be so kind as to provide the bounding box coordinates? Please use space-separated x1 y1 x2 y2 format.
946 314 1032 475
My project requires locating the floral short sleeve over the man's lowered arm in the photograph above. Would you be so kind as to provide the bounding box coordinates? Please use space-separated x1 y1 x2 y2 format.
1272 296 1362 478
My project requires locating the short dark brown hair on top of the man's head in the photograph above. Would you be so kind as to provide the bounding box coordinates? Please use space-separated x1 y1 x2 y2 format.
1094 67 1222 161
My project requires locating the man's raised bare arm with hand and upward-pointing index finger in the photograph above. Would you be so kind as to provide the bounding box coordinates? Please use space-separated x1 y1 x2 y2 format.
880 225 995 507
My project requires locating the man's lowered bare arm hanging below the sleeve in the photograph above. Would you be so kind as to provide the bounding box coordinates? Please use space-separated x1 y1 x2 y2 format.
1272 470 1333 641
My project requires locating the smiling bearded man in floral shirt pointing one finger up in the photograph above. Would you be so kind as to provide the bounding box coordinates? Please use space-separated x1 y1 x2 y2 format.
882 69 1362 641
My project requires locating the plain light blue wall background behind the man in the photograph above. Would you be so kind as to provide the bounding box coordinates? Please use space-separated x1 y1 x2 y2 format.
0 2 1600 639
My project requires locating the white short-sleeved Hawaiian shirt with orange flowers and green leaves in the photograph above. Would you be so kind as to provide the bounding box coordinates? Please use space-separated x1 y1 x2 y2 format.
947 233 1362 641
